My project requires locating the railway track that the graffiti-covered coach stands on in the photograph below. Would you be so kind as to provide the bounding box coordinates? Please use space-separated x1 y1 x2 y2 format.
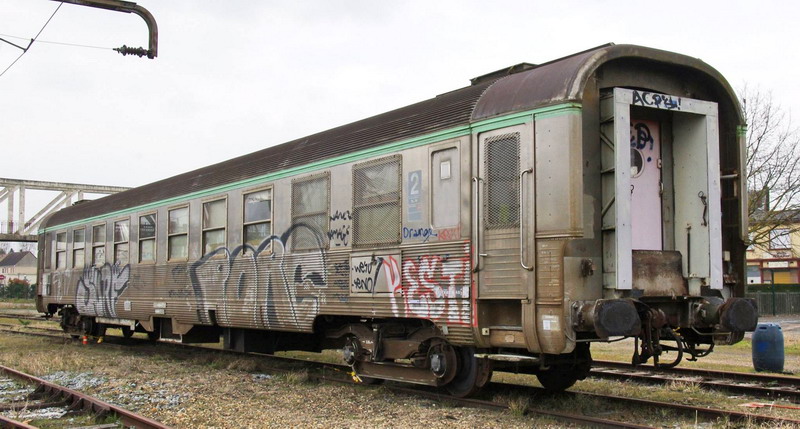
0 328 800 428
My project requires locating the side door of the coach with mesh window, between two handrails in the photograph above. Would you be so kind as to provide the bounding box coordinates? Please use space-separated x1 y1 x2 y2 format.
475 125 535 299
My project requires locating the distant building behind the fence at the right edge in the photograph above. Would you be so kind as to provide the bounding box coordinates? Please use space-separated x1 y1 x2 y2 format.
747 211 800 284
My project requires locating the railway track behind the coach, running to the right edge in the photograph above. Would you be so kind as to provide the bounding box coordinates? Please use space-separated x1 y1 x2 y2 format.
590 361 800 403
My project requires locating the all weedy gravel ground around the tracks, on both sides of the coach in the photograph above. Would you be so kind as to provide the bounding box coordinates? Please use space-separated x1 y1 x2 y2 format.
0 303 800 428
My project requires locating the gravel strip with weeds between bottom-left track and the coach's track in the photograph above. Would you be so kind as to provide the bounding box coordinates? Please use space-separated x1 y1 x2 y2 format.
0 333 544 428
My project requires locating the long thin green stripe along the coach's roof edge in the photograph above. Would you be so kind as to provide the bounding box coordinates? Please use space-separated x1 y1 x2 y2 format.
39 103 581 234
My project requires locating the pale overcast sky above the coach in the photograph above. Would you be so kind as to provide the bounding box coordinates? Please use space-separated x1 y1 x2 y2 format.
0 0 800 241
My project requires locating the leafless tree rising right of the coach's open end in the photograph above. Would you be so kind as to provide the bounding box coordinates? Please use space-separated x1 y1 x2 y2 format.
740 85 800 243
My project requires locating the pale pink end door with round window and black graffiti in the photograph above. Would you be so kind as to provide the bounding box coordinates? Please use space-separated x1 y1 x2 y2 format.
630 120 663 250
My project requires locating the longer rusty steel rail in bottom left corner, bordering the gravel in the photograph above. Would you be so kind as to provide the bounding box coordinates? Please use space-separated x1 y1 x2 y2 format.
0 365 169 429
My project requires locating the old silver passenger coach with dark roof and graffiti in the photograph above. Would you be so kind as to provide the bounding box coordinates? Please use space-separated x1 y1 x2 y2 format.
37 45 758 395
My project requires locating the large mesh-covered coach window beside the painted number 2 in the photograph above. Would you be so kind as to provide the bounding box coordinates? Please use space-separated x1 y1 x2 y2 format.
353 155 403 247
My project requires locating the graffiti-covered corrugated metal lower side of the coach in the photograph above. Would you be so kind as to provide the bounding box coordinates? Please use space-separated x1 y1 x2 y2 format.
48 242 473 344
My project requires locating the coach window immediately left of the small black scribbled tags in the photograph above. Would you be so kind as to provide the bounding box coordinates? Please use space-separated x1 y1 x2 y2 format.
292 173 330 250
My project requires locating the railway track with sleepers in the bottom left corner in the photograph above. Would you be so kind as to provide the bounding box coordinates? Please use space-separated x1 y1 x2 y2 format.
0 365 169 429
